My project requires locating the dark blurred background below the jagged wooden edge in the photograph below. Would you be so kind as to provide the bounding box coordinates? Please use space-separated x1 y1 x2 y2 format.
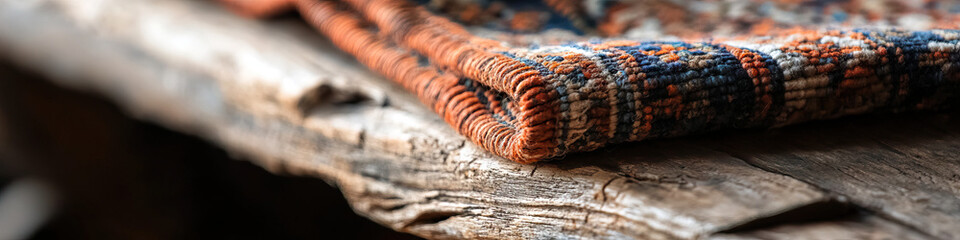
0 62 414 239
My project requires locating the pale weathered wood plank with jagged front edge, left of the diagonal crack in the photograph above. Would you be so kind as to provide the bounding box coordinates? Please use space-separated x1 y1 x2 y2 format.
0 0 944 239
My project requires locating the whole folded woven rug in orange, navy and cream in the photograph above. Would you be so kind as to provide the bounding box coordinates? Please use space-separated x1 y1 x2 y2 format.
221 0 960 163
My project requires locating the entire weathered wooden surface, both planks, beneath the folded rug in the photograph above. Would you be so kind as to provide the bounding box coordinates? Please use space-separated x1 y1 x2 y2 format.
0 0 960 239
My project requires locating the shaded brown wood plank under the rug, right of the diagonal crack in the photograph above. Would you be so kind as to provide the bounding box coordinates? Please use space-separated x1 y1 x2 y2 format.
703 112 960 239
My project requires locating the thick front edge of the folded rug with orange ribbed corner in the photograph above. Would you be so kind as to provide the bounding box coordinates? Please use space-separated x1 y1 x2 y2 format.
220 0 960 163
